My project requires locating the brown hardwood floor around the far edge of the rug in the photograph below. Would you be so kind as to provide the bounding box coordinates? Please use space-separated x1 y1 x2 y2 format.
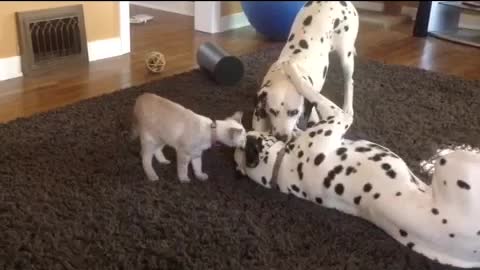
0 6 480 122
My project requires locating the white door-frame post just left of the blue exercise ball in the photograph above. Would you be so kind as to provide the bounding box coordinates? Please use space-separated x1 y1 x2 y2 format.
194 1 221 33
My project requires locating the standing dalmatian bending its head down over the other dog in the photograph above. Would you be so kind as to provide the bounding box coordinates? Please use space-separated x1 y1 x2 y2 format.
252 1 359 140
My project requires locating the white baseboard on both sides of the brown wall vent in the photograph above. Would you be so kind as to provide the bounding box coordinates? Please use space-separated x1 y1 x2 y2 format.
0 37 126 81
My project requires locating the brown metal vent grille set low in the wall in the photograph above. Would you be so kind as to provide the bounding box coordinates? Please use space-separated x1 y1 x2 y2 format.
16 5 88 75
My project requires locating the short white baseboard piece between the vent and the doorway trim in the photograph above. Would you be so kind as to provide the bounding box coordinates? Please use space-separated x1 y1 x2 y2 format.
88 37 123 62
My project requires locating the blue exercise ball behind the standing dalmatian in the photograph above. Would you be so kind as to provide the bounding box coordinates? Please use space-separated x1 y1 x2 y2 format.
241 1 306 41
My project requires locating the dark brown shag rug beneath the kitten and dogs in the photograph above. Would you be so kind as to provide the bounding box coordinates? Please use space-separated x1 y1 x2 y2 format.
0 47 480 270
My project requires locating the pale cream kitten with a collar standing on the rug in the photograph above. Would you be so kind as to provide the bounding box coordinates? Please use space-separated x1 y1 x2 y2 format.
132 93 246 183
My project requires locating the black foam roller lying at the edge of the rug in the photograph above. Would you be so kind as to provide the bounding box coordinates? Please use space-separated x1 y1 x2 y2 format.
197 42 244 85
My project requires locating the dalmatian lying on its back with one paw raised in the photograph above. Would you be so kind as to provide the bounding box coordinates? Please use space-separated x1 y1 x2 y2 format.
234 61 480 268
